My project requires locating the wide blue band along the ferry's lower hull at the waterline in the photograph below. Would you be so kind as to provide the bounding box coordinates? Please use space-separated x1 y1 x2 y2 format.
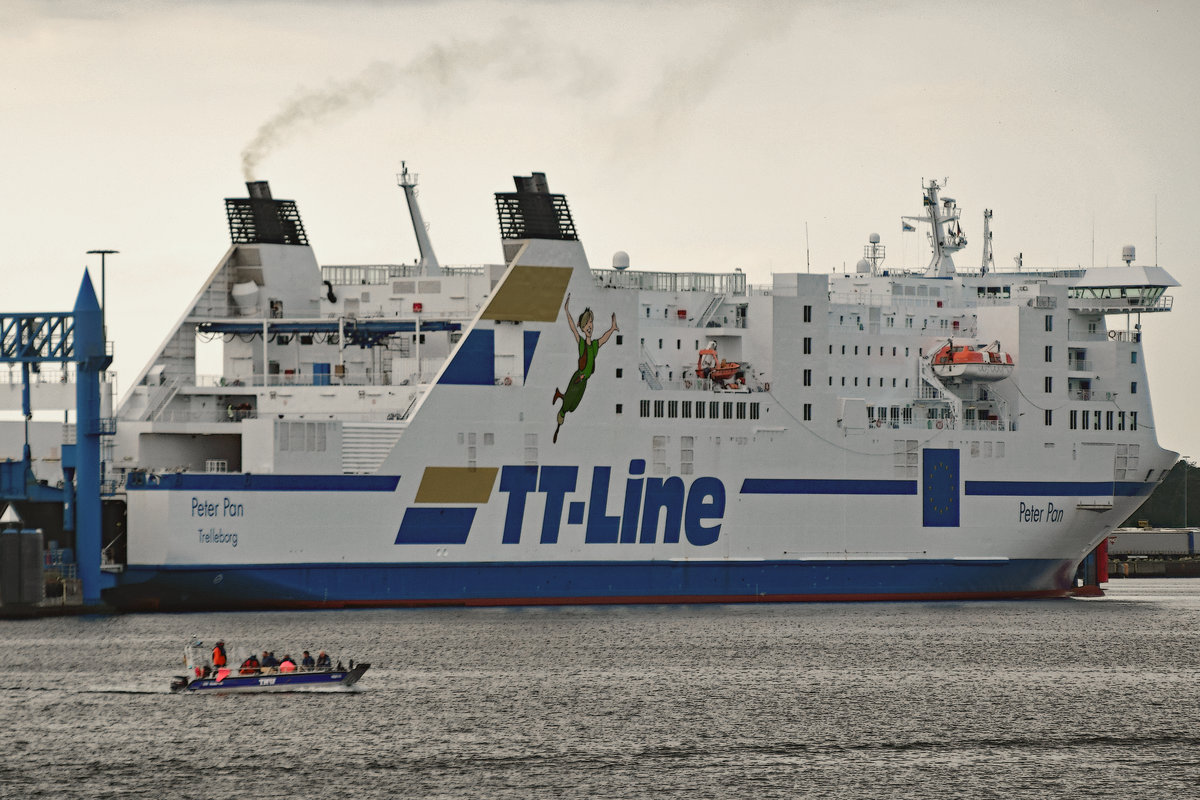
104 559 1075 608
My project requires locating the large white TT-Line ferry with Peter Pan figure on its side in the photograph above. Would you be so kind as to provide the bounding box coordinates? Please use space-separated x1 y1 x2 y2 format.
44 168 1178 609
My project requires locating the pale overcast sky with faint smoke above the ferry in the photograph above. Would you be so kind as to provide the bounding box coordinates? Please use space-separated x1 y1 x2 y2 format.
0 0 1200 457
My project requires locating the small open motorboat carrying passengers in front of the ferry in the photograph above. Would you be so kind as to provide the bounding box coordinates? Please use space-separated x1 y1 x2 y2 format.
170 640 371 694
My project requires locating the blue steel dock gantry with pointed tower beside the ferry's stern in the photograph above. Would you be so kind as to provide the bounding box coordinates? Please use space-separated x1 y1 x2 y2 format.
0 270 113 606
